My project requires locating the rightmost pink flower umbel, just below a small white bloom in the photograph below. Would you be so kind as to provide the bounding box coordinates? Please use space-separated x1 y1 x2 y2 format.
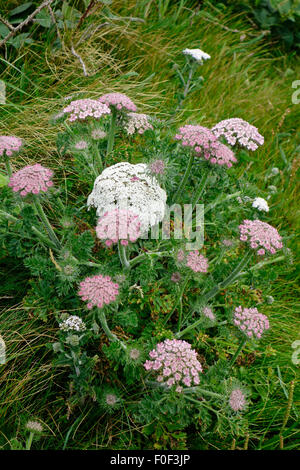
239 219 283 256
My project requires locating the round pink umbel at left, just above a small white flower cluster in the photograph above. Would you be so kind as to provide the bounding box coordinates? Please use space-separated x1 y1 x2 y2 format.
78 274 119 309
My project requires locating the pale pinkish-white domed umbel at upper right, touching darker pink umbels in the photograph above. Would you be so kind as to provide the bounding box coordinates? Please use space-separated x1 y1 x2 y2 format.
212 118 264 151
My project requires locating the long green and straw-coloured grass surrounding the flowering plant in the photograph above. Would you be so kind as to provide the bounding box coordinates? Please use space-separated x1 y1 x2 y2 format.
0 0 300 450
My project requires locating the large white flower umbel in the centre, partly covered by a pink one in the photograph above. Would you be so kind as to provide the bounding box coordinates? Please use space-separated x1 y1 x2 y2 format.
87 162 167 232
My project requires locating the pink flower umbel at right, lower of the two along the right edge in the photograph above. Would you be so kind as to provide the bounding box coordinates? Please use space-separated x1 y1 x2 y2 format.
233 306 270 339
